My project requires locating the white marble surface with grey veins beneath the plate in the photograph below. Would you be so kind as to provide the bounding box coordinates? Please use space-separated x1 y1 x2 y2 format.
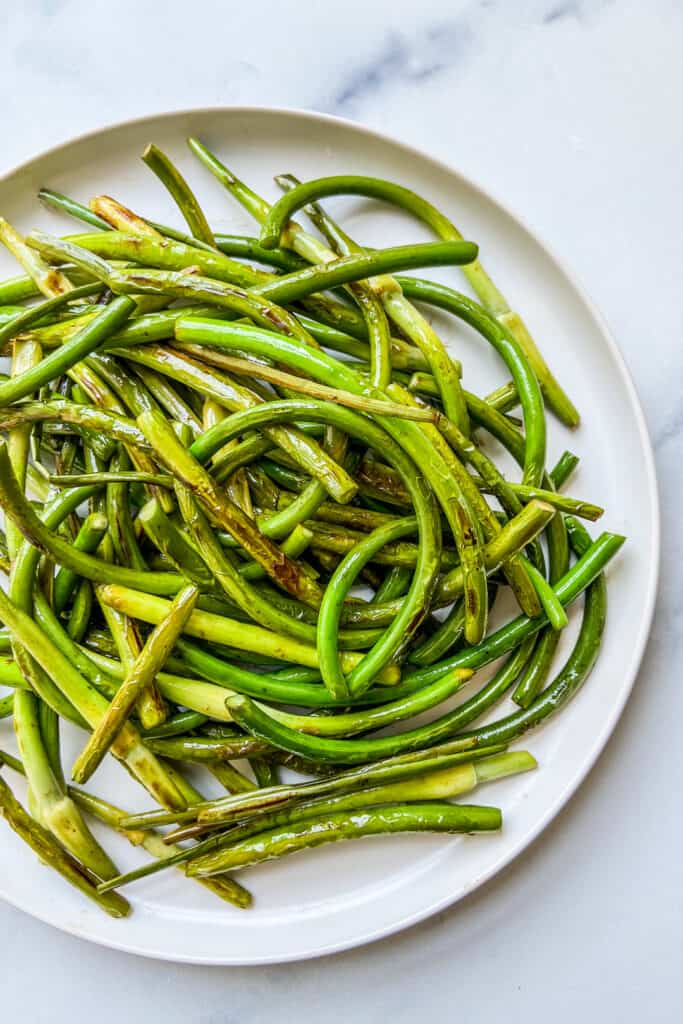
0 0 683 1024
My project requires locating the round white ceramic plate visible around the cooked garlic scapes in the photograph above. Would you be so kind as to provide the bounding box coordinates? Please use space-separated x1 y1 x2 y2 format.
0 109 658 964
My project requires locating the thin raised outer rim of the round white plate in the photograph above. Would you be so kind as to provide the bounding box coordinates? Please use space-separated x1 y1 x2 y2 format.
0 103 661 967
